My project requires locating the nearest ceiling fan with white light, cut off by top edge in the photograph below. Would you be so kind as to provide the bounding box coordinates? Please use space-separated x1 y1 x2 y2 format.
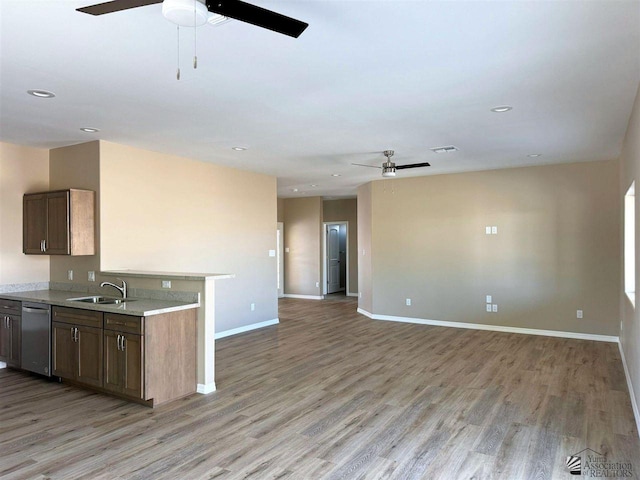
77 0 309 38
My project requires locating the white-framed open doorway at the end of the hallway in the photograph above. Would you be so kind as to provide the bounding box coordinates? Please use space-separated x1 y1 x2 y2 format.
322 222 349 295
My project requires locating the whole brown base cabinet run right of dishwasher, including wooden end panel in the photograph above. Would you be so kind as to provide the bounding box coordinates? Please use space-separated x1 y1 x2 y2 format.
52 307 197 407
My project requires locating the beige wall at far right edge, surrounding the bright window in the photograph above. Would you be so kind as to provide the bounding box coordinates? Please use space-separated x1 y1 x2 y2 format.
619 81 640 422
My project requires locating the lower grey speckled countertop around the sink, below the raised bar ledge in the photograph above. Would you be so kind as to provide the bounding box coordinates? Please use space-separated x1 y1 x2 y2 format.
0 290 200 317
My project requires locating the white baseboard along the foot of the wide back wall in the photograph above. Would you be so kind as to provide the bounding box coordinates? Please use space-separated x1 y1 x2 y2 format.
358 308 618 343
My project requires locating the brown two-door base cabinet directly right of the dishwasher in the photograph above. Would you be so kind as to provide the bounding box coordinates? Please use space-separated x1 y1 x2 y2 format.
51 307 103 387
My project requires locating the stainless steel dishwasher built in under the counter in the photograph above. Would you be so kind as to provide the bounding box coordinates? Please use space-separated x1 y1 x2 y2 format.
22 302 51 377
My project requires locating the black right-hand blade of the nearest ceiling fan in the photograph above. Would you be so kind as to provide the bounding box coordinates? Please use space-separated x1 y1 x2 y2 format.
206 0 309 38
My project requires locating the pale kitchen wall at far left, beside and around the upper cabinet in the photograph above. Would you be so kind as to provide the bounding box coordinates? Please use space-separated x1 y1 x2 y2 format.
0 142 49 286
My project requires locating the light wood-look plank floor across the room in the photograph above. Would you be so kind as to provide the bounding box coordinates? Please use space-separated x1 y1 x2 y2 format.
0 297 640 480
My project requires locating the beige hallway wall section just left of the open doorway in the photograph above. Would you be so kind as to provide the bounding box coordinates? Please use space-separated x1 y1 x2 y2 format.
284 197 322 296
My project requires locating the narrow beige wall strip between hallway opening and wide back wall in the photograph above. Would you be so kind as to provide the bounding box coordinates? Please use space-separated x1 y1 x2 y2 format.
358 182 373 313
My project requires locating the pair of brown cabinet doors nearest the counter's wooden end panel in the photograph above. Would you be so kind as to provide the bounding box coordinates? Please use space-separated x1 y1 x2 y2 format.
104 330 144 399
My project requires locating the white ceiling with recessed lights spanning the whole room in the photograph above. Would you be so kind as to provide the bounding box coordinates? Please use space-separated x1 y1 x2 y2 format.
0 0 640 197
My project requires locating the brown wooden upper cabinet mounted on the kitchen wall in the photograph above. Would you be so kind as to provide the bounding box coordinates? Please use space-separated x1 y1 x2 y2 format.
22 189 96 255
